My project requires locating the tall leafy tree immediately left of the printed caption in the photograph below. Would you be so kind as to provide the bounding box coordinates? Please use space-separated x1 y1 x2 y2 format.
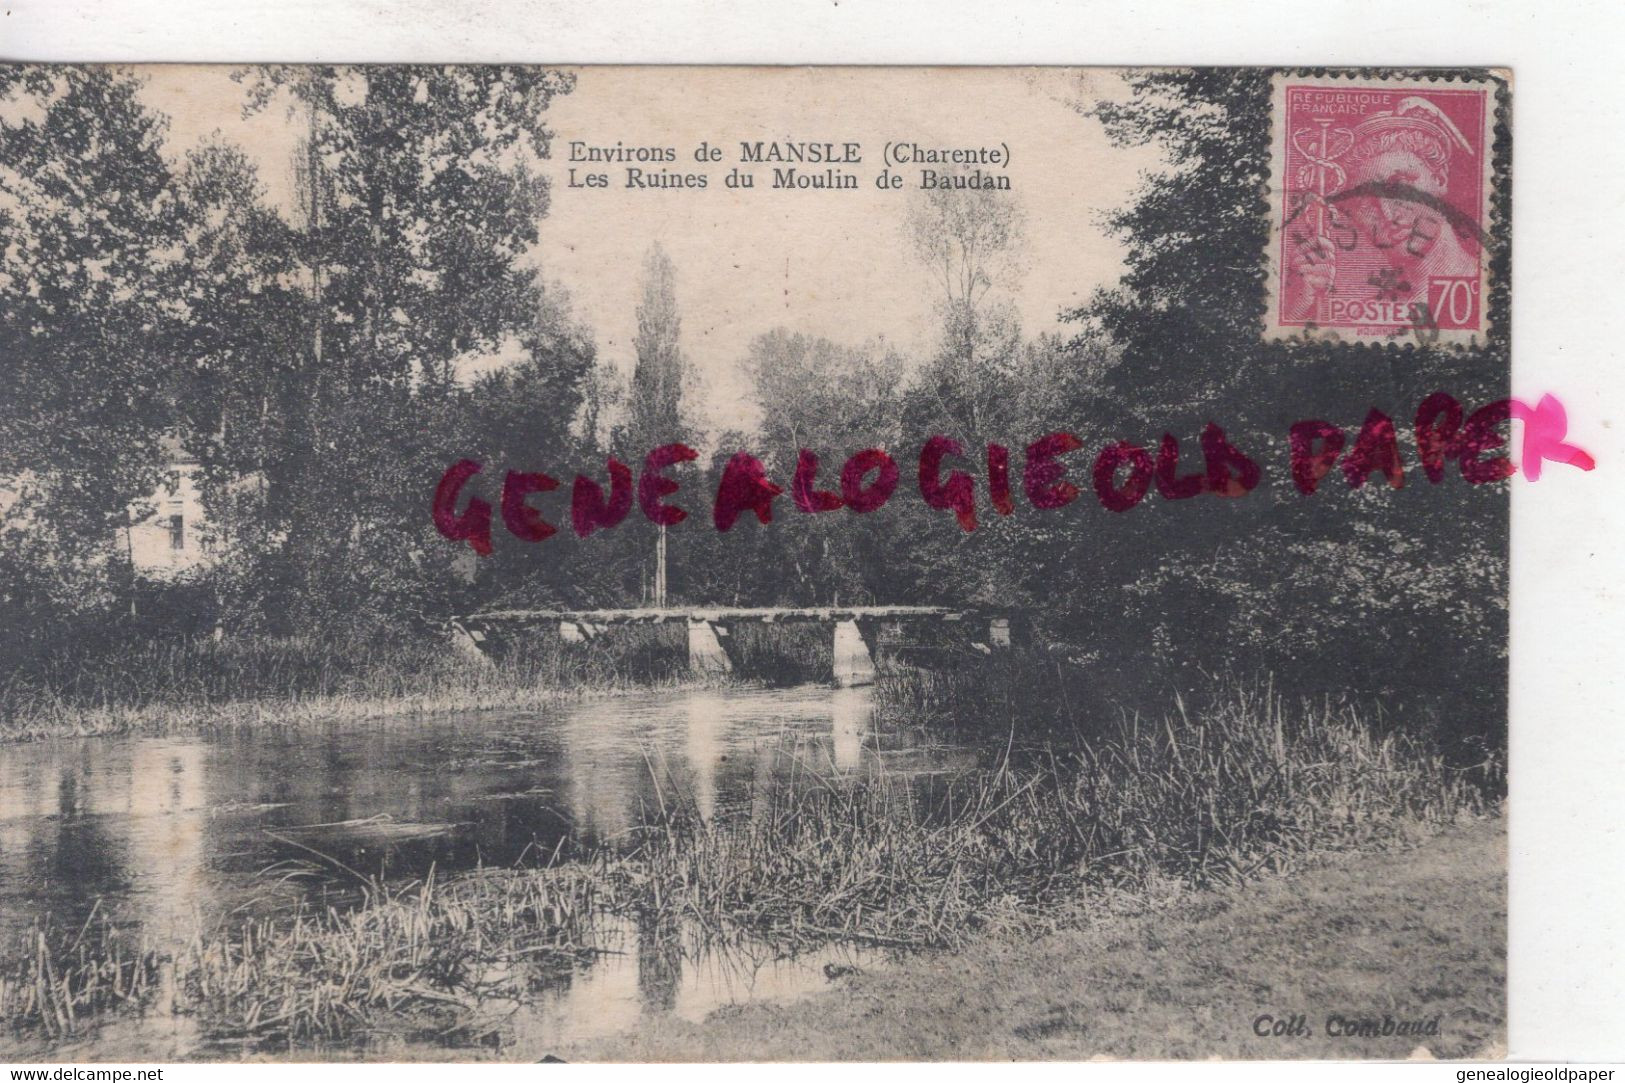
224 65 582 624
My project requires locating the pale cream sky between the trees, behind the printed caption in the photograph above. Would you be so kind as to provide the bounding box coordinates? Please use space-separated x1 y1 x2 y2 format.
145 67 1159 429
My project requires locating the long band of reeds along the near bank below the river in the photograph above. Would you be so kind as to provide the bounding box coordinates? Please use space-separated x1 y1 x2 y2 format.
0 682 1497 1049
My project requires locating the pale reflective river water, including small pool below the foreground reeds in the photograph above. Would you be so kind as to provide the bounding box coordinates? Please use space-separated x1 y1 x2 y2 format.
0 688 975 1054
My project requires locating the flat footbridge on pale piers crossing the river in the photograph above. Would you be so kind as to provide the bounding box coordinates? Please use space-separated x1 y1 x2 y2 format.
452 605 1021 688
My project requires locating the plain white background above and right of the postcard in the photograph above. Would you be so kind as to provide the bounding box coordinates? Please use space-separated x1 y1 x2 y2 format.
0 0 1625 1066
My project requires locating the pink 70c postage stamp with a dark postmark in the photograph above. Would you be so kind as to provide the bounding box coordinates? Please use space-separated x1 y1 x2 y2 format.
1266 75 1495 345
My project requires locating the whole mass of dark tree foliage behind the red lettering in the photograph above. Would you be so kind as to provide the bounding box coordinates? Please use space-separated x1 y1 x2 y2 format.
0 67 1510 738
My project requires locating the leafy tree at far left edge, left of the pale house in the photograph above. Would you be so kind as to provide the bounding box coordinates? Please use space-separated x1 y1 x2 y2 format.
0 67 200 643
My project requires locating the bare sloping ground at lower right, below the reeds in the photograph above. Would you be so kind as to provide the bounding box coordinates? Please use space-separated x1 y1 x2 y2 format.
556 820 1506 1060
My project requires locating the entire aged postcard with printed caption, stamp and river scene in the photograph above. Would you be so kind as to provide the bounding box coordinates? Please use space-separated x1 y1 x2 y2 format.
0 65 1514 1062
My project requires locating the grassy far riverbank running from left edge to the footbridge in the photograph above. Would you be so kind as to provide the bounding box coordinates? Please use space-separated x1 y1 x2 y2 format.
0 624 829 742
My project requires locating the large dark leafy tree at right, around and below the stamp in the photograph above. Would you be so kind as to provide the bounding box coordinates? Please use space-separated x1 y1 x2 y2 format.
1047 68 1508 735
